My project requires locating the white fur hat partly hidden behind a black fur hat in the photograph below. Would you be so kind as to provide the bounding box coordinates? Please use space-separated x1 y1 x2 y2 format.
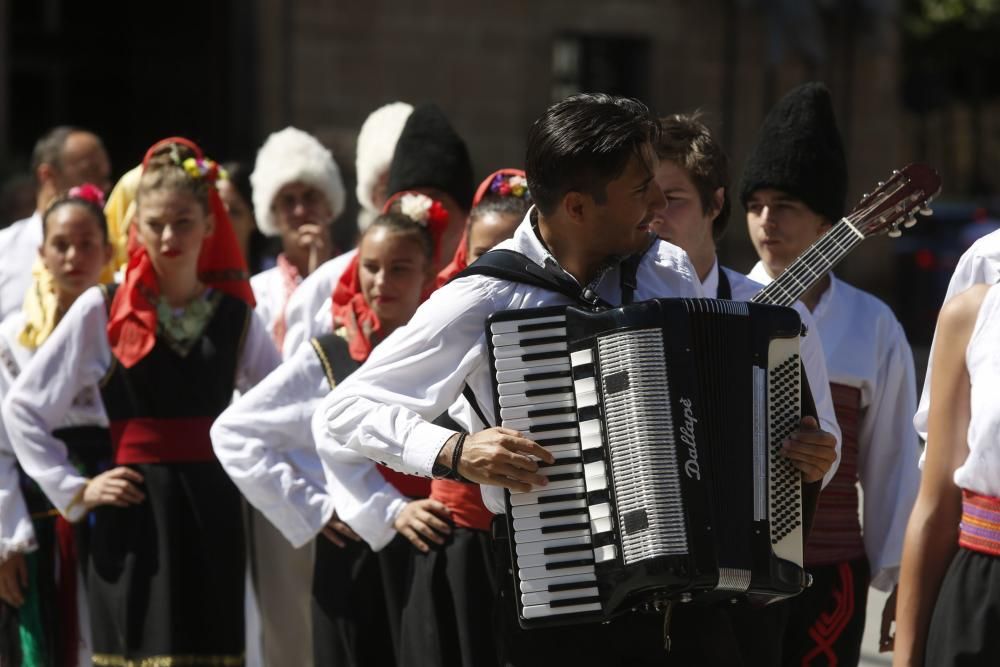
354 102 413 214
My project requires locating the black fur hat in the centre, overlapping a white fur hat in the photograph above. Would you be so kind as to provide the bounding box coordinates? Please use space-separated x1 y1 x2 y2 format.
389 104 476 211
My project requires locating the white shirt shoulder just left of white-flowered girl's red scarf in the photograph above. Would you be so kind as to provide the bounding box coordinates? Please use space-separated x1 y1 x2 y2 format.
278 248 358 359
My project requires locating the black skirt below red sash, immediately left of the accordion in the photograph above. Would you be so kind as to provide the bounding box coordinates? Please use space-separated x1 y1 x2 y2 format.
399 528 497 667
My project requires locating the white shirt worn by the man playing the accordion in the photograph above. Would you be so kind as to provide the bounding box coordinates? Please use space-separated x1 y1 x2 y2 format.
313 213 702 512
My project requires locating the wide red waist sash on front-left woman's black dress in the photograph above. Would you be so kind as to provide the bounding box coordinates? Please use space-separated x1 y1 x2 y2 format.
110 417 216 465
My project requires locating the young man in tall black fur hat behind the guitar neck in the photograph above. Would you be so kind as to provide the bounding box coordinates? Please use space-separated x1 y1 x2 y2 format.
740 83 919 665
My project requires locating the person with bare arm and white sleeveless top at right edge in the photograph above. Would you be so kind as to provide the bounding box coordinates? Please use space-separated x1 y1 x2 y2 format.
893 285 1000 667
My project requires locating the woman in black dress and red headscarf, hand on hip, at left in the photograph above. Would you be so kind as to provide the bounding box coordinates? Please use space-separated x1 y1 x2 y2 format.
3 138 278 666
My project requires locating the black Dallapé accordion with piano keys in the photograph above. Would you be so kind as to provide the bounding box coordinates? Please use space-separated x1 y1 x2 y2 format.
486 299 806 628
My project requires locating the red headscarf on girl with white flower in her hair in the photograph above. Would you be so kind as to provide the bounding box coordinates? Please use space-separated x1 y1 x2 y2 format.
333 190 448 362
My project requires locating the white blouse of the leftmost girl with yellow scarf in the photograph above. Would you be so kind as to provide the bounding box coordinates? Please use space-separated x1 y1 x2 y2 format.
0 312 108 562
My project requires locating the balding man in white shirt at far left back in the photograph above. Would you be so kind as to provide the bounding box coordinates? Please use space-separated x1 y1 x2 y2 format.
0 126 111 321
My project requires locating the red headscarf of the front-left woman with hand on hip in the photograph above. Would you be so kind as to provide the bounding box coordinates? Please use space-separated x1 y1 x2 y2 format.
107 137 255 368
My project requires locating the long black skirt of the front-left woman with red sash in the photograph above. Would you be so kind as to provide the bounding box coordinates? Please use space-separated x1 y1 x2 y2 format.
88 462 245 667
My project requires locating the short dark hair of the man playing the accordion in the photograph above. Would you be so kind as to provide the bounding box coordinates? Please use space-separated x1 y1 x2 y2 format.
524 93 660 214
